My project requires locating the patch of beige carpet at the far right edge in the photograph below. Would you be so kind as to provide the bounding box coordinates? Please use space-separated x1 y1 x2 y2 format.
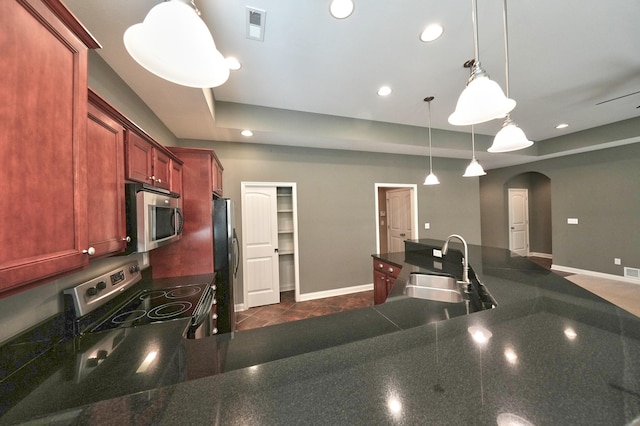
565 275 640 317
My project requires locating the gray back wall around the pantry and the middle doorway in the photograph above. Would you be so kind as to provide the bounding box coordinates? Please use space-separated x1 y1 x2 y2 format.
180 140 480 302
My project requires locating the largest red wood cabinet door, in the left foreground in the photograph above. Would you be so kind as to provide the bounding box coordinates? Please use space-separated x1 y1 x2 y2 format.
0 0 88 291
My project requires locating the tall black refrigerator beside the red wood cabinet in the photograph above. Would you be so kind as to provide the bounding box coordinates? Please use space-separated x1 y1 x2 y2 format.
213 196 240 333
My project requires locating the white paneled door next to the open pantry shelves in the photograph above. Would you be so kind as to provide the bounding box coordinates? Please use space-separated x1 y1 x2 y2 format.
241 184 280 308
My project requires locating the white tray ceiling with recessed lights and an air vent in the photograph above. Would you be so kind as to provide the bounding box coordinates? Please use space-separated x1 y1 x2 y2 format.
64 0 640 168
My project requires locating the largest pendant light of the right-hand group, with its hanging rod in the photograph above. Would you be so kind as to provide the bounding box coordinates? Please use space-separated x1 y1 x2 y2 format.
449 0 516 126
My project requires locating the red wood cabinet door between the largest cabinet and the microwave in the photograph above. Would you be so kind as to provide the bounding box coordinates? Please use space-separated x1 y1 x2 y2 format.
87 105 126 256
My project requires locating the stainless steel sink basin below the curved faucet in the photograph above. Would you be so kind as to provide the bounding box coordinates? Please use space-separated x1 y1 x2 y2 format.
404 273 464 303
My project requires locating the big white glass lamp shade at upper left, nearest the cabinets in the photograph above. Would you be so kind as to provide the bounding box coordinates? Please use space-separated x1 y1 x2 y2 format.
124 0 229 88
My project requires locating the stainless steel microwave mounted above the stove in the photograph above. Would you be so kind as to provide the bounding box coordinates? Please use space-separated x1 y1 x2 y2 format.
126 184 184 253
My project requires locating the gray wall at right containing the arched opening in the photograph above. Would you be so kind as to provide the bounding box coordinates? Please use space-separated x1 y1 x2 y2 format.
480 143 640 275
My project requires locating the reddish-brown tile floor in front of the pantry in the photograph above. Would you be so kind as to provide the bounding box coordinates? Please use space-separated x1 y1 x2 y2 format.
236 290 373 331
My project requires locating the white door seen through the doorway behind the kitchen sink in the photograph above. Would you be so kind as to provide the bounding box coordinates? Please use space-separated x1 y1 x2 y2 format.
387 188 413 253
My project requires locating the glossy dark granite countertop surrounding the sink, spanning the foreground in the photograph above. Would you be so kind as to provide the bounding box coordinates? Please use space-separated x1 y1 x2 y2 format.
0 240 640 425
